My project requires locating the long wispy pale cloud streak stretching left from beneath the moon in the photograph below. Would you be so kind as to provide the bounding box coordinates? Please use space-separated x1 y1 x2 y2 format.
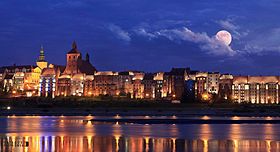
136 27 237 56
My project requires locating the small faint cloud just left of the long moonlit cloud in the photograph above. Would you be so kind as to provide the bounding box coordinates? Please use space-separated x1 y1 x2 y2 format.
108 24 131 42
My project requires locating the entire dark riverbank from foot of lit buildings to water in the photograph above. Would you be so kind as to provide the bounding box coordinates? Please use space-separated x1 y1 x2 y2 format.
0 97 280 117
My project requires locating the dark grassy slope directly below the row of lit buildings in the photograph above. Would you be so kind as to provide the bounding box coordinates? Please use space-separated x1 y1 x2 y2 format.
0 97 280 110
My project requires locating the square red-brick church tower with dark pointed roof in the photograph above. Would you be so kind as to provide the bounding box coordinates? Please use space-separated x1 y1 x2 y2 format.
64 41 82 75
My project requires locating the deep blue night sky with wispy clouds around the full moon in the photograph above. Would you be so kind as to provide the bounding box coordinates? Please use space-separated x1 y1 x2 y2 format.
0 0 280 75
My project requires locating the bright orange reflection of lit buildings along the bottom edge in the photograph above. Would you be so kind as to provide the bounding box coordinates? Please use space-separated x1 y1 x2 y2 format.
0 136 280 152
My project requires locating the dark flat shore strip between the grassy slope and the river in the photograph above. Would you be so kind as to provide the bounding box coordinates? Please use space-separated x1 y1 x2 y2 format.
0 107 280 117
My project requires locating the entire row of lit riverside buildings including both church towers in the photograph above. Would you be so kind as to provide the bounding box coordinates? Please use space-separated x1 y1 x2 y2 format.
0 42 280 104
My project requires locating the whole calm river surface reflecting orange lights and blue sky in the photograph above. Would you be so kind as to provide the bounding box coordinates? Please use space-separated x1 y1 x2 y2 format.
0 116 280 152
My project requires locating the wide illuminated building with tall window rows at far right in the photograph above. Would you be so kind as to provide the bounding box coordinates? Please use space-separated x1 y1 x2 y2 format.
232 76 279 104
